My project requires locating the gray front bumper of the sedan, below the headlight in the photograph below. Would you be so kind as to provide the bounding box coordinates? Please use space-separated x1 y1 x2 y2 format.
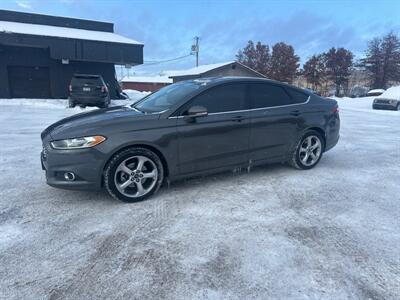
40 146 104 190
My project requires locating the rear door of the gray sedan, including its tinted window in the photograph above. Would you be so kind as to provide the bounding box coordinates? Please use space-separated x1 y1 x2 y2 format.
249 83 301 162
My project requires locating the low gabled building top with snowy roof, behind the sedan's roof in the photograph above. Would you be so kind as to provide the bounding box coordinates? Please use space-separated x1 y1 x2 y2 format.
169 61 265 82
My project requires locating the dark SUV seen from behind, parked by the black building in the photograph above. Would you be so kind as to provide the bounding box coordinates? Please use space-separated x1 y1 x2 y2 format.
69 74 111 108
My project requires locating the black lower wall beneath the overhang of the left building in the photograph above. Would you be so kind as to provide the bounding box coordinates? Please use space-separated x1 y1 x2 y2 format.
0 45 119 98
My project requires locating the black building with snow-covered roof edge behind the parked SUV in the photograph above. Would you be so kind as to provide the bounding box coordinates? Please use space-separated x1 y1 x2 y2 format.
0 10 143 98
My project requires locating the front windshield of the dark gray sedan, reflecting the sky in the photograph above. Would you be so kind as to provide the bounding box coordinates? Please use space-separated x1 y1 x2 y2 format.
132 81 201 113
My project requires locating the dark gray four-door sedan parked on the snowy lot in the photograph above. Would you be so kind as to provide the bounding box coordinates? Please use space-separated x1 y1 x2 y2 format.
41 77 340 202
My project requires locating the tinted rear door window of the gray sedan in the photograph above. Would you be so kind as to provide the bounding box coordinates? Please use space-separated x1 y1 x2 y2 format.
250 83 294 108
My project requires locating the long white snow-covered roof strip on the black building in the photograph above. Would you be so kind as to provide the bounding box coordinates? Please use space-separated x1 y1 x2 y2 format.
0 21 142 45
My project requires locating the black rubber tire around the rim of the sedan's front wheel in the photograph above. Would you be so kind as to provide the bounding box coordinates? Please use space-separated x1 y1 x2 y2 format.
104 147 164 203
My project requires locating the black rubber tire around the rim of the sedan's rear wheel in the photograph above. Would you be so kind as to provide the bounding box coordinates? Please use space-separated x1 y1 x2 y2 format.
288 130 325 170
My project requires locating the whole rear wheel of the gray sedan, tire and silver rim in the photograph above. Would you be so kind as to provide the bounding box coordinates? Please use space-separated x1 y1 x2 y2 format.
289 130 325 170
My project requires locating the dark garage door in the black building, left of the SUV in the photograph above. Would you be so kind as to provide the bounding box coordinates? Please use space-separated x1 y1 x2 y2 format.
8 66 50 98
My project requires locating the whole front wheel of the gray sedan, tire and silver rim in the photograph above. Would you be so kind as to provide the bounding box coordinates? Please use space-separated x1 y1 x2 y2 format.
104 148 164 202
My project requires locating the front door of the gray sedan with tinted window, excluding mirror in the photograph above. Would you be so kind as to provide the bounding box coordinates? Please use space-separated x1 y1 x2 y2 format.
177 84 250 174
